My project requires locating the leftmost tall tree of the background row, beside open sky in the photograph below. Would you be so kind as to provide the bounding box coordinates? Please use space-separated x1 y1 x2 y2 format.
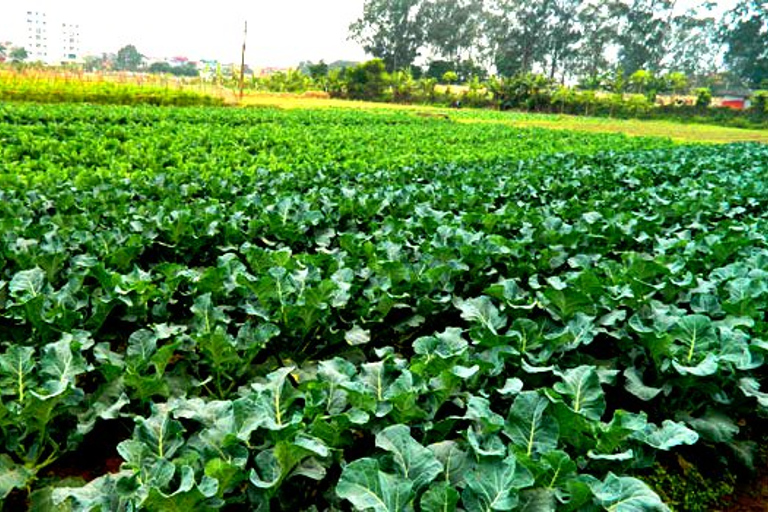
349 0 424 72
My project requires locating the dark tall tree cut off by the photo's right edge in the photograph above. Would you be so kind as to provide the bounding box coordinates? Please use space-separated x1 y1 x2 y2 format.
720 0 768 88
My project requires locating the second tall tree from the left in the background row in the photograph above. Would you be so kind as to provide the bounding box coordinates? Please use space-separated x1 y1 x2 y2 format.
421 0 483 65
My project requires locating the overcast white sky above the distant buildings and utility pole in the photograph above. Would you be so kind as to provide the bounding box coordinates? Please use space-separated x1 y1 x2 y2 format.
0 0 735 67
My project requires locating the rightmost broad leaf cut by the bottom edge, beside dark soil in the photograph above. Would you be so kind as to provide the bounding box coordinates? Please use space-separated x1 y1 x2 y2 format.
589 473 669 512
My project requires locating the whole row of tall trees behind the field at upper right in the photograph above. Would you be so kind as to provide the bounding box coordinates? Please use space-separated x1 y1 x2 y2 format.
349 0 768 88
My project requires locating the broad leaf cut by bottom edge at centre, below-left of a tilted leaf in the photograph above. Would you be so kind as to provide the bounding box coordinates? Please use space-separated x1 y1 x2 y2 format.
336 459 413 512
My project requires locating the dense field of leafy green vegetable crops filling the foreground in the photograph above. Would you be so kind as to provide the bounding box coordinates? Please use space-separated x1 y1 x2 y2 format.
0 105 768 512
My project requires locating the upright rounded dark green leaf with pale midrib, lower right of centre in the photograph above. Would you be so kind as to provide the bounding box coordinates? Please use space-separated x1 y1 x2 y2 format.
504 391 559 457
